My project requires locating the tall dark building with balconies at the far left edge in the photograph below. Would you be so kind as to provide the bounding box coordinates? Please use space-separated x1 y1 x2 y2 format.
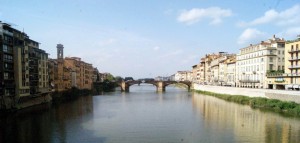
0 22 50 109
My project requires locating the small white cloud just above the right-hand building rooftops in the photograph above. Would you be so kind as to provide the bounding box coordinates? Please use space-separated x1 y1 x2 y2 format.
237 28 267 45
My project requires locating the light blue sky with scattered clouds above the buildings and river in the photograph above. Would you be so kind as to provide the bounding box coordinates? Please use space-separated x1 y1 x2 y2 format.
0 0 300 78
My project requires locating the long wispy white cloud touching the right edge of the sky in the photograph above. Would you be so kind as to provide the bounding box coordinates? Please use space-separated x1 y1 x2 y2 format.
238 5 300 26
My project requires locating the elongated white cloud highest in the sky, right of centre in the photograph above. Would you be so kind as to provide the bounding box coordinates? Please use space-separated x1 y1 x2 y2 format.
177 7 232 25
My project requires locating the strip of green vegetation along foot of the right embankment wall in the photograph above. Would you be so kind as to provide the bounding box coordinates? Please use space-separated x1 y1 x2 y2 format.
195 90 300 117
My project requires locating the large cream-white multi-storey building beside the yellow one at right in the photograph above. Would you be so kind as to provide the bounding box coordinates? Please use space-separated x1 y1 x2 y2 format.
236 35 285 88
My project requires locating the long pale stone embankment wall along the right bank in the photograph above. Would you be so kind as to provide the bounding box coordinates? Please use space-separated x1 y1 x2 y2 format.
193 84 300 103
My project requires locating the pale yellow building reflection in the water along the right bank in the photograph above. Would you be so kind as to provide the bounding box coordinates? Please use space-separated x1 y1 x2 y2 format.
192 93 300 143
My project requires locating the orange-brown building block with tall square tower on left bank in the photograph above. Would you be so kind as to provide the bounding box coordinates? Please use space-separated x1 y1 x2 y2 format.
48 44 94 91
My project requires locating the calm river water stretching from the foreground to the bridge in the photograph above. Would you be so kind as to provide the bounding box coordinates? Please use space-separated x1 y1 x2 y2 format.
0 85 300 143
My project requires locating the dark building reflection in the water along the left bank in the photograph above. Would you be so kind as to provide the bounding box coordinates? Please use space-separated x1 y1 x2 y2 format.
0 96 93 143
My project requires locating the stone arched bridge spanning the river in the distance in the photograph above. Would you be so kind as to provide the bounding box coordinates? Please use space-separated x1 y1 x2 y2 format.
118 80 192 92
